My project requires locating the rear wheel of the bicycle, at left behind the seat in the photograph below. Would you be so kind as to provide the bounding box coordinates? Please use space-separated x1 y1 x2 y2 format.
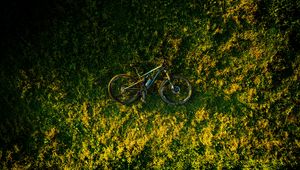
108 74 141 105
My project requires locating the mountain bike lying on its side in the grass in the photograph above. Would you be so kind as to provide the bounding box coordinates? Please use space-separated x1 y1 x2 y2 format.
108 62 192 105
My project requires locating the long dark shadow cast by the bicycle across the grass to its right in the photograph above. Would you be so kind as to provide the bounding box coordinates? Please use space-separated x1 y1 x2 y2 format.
140 89 246 119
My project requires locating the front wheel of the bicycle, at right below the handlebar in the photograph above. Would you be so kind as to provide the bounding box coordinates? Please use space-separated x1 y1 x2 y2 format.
159 76 192 105
